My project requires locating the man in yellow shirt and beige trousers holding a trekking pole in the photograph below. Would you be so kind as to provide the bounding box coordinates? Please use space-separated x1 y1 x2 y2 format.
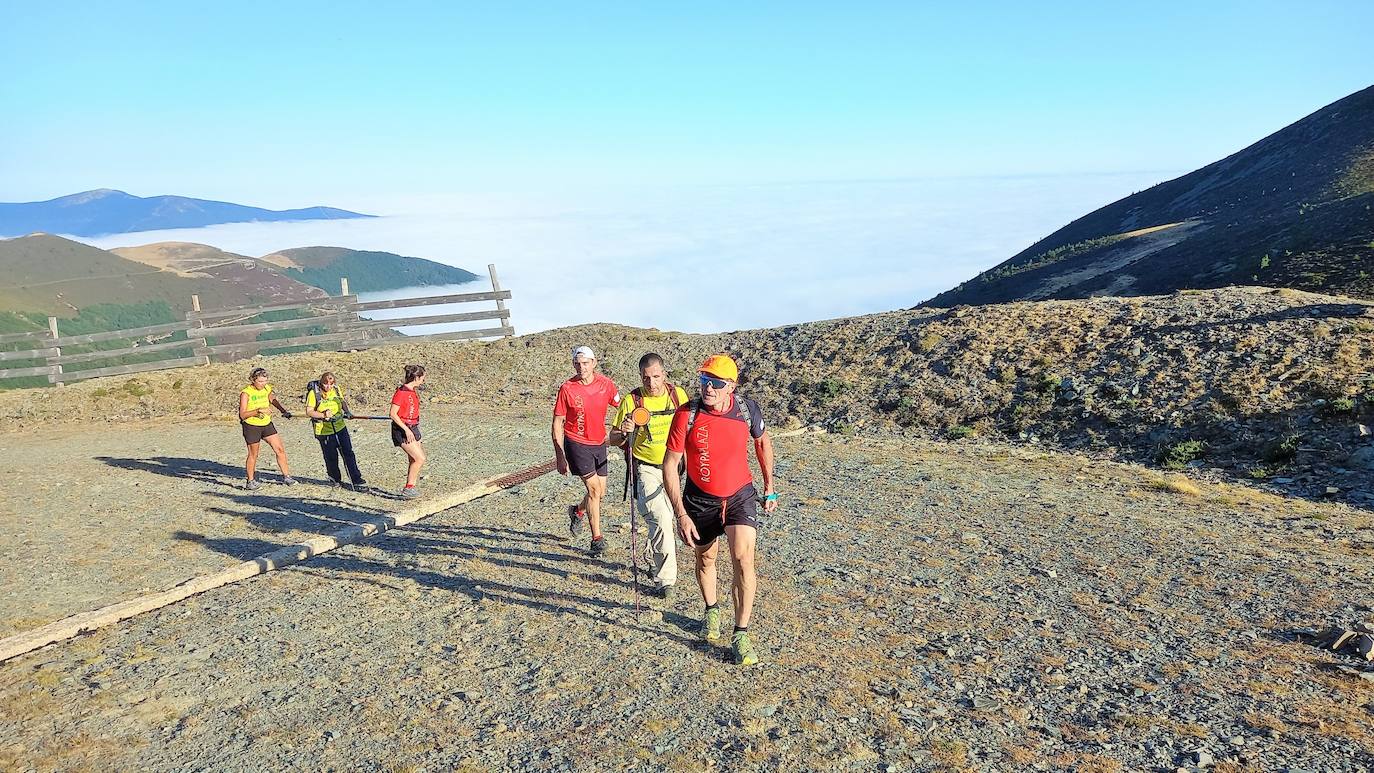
609 351 687 599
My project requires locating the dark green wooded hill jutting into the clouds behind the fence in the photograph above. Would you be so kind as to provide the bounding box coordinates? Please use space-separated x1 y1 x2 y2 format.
262 247 477 292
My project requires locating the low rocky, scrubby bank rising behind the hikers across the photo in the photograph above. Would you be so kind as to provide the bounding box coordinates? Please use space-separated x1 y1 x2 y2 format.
0 287 1374 501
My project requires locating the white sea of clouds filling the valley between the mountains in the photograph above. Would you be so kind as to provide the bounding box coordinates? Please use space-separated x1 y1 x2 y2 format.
82 172 1173 332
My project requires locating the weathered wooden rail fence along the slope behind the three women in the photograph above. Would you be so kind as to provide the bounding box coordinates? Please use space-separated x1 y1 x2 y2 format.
0 265 515 386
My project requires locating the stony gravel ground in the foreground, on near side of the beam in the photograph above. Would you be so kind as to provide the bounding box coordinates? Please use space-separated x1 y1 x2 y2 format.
0 425 1374 770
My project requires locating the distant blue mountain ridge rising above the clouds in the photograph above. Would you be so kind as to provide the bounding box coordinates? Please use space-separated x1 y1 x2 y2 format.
0 188 375 236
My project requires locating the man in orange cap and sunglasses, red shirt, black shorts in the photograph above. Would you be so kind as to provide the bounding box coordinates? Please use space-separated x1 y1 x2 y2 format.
664 354 778 666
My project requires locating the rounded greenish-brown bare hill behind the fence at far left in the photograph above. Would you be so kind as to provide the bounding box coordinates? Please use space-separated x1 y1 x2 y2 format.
0 233 324 317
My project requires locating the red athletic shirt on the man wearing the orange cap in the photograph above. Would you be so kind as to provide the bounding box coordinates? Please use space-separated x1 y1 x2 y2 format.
668 395 764 498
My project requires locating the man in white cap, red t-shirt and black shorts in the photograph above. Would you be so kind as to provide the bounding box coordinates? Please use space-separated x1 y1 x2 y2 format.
554 346 620 555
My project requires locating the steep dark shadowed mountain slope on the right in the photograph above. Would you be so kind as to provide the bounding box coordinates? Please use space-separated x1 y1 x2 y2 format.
922 86 1374 306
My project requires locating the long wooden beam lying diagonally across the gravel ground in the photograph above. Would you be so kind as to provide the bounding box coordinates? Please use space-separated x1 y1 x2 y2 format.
0 461 554 662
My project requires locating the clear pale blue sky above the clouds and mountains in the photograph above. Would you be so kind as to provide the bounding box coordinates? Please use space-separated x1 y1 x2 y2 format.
0 0 1374 211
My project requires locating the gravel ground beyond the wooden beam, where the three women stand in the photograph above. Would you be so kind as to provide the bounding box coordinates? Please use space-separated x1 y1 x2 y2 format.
0 405 552 636
